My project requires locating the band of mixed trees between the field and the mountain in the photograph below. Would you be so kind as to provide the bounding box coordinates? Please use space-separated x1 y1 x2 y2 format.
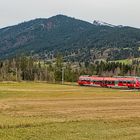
0 55 140 83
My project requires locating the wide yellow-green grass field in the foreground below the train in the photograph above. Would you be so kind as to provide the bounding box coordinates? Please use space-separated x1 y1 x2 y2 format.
0 83 140 140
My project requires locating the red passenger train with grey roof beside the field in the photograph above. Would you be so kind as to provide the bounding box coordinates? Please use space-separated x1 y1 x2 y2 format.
78 76 140 89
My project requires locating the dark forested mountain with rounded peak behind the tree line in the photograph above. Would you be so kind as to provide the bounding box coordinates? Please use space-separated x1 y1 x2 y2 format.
0 15 140 62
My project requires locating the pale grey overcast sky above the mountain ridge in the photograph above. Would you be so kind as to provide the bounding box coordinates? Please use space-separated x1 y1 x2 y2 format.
0 0 140 28
